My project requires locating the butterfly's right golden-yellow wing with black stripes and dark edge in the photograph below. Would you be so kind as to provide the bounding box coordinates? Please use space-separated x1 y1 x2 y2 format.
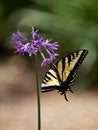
57 50 87 82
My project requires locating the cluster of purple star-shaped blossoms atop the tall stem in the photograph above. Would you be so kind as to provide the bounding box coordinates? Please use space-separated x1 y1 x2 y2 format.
12 27 59 66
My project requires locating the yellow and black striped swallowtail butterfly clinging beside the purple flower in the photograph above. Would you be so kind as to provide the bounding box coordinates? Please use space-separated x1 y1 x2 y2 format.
41 49 88 101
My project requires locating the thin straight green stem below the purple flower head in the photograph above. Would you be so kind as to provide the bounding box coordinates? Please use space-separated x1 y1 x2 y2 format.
35 56 41 130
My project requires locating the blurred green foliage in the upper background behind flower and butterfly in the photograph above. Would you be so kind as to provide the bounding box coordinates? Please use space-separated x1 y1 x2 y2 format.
0 0 98 91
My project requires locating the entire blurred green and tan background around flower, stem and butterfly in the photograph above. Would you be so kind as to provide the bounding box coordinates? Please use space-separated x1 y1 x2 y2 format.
0 0 98 130
